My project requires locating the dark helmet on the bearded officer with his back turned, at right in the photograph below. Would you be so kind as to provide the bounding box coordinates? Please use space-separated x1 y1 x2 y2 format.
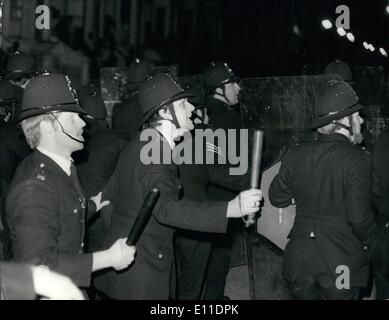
311 80 364 128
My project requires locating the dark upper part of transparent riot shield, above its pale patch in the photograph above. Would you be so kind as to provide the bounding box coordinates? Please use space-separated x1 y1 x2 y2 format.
240 75 340 169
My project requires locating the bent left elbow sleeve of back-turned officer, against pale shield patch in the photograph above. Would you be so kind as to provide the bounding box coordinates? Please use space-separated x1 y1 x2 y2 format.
269 157 293 208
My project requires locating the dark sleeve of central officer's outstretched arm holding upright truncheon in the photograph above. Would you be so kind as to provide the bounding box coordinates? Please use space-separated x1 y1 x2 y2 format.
141 164 228 233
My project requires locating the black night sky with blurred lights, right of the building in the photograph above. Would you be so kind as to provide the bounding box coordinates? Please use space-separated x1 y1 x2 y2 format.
181 0 389 76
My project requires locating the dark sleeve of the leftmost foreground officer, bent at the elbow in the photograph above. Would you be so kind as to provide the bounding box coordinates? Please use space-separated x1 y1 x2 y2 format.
6 180 92 286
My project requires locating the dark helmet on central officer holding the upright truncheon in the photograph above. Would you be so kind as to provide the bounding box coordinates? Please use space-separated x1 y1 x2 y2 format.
138 73 193 122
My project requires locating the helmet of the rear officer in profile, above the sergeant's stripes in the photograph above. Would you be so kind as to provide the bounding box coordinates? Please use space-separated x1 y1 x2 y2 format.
203 62 239 92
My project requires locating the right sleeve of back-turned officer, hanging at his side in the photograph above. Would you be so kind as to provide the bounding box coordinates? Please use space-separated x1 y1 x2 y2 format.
346 154 375 245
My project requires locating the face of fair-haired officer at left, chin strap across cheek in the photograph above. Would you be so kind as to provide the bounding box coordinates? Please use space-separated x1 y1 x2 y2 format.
57 112 85 152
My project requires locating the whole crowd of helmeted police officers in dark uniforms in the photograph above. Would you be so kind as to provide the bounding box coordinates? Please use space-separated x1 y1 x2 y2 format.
0 52 389 300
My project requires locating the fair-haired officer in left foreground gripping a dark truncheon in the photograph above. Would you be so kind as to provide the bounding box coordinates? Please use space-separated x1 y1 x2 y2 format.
6 73 135 287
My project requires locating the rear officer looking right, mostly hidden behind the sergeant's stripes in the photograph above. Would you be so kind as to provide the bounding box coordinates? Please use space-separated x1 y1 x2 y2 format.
203 62 242 300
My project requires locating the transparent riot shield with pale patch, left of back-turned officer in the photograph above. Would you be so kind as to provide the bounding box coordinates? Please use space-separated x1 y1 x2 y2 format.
240 76 338 299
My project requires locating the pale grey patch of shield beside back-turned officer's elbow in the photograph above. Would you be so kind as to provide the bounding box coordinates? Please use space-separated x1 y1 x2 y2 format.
257 162 296 250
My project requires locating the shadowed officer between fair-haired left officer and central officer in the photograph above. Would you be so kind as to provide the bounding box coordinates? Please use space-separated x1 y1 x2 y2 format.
73 84 127 252
